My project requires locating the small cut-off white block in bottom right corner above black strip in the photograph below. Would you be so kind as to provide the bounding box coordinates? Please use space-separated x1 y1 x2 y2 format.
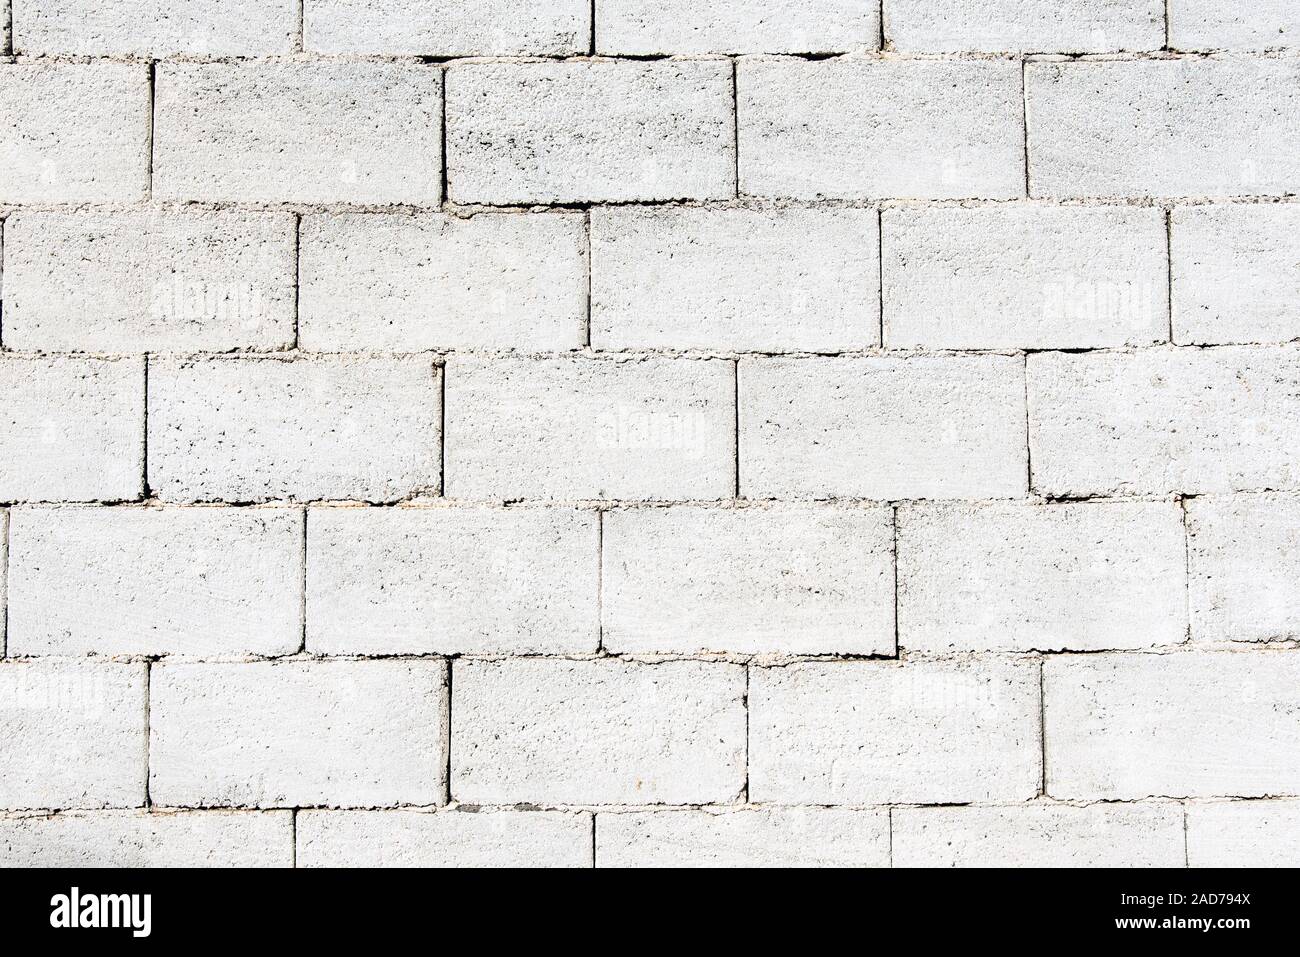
1187 801 1300 867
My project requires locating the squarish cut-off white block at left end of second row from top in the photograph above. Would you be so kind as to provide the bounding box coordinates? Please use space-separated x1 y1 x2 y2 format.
0 61 150 203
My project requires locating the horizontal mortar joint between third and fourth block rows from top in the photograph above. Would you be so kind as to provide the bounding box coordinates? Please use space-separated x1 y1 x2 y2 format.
0 339 1300 365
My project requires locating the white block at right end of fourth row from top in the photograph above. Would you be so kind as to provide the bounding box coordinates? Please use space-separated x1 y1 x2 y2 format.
1028 346 1300 495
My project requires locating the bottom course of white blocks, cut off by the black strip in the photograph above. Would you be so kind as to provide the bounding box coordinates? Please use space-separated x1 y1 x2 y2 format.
0 801 1300 867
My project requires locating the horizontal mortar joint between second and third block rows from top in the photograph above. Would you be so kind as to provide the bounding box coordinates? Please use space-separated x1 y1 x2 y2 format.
0 192 1300 220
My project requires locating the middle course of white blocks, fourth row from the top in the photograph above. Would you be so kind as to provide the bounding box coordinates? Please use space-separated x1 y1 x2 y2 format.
0 346 1300 503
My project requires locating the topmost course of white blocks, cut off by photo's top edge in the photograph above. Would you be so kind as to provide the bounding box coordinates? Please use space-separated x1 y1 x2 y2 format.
5 0 1300 56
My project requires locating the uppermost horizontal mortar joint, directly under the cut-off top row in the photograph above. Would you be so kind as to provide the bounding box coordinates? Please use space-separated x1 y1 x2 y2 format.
0 44 1300 68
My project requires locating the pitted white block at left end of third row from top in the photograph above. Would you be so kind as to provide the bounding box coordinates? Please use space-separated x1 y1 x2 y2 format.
4 212 295 352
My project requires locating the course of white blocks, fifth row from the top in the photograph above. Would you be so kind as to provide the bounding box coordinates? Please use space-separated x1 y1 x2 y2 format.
5 494 1300 658
